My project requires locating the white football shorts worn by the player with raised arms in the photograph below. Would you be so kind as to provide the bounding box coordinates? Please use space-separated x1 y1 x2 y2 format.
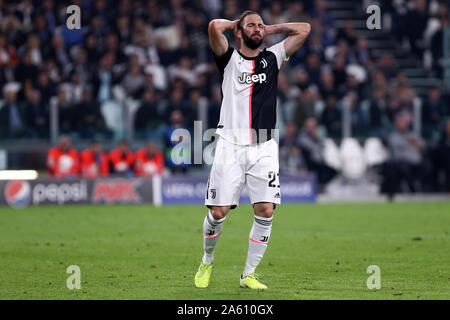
205 136 281 209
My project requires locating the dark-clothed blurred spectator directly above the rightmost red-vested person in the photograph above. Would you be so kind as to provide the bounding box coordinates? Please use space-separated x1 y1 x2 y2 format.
134 89 164 137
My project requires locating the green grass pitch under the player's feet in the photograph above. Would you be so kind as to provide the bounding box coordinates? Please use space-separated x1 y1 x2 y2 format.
0 202 450 300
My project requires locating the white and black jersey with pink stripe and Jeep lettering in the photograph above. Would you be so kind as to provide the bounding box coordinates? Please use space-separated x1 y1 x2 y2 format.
215 41 288 145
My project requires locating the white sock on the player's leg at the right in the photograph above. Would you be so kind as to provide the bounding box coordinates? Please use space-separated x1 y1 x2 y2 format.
242 215 272 278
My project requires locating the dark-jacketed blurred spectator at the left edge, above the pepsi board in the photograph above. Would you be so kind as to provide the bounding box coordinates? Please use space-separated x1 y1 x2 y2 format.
0 82 26 138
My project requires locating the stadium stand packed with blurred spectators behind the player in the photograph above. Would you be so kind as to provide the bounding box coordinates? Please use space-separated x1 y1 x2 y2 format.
0 0 450 192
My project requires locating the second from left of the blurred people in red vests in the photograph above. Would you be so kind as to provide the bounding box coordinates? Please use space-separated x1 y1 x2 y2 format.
80 141 109 179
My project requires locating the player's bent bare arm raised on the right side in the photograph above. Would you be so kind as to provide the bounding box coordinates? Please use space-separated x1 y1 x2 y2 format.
265 22 311 57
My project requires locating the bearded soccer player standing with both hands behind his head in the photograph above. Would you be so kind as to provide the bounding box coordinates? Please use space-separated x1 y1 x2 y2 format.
195 11 311 290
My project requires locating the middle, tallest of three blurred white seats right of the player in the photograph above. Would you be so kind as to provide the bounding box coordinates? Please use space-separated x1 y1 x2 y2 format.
341 138 366 180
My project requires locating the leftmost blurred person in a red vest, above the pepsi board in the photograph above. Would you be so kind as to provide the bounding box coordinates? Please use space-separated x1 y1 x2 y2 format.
47 136 79 178
